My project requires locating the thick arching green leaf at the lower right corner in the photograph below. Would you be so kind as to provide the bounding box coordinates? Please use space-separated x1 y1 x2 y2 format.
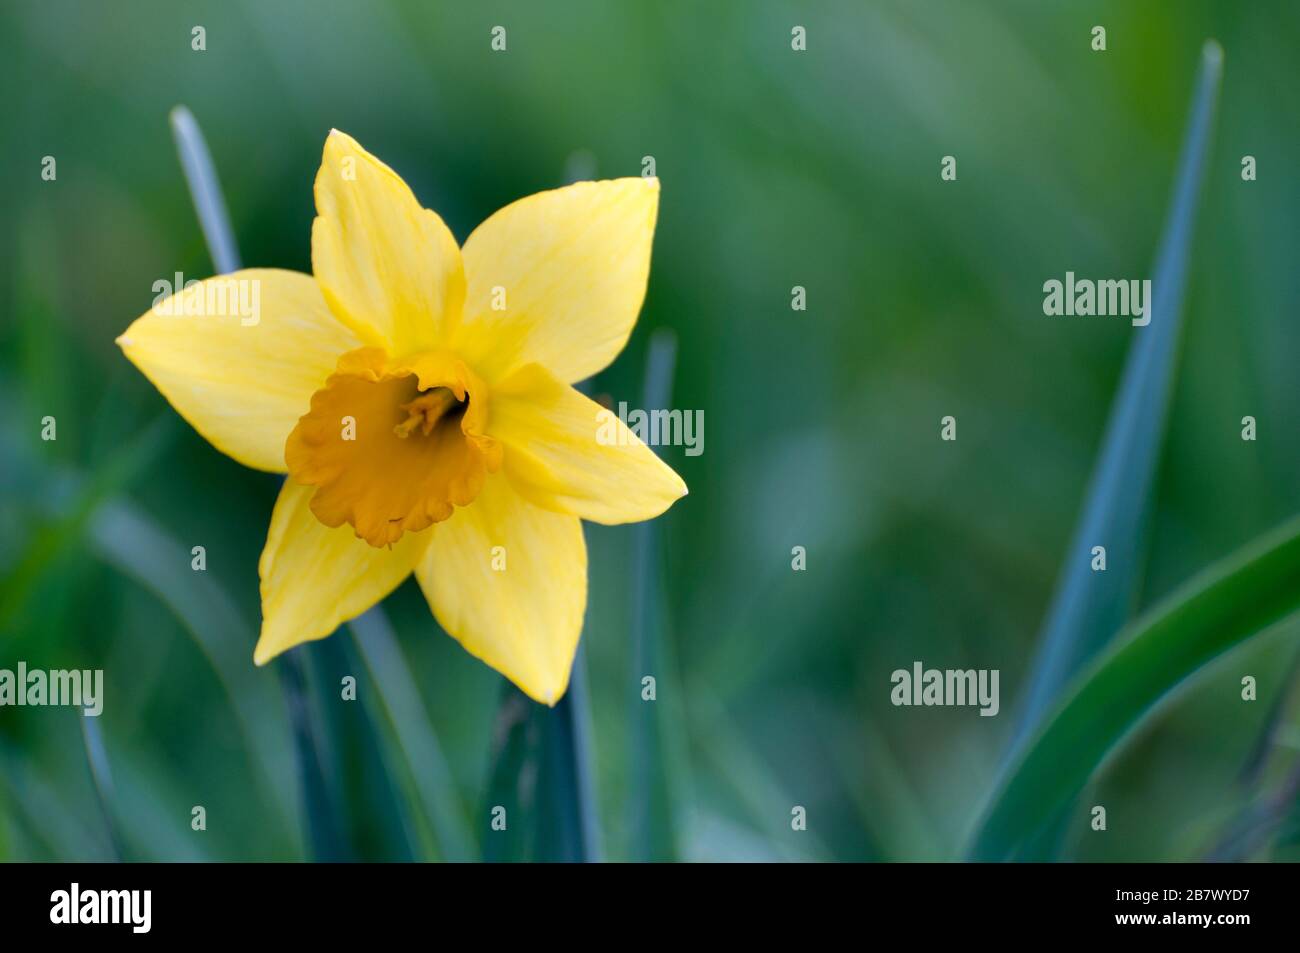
971 519 1300 861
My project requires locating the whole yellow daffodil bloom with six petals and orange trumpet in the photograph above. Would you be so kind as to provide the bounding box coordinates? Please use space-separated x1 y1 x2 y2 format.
118 130 686 705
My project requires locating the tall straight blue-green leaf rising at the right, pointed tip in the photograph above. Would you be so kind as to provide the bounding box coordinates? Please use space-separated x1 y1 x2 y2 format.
1015 42 1223 740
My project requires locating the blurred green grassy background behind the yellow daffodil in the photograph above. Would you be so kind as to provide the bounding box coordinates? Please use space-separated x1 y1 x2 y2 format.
0 0 1300 859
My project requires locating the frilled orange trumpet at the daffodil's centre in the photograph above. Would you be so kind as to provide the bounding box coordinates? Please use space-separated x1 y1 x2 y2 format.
285 347 502 546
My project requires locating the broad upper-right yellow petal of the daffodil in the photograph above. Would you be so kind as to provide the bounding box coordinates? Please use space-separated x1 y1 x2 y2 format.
452 178 659 382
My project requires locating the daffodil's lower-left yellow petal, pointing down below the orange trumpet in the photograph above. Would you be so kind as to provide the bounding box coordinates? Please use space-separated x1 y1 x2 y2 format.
252 480 429 666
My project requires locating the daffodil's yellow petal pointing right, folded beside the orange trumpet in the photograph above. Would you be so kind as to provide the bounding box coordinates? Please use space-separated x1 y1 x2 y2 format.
488 364 686 524
